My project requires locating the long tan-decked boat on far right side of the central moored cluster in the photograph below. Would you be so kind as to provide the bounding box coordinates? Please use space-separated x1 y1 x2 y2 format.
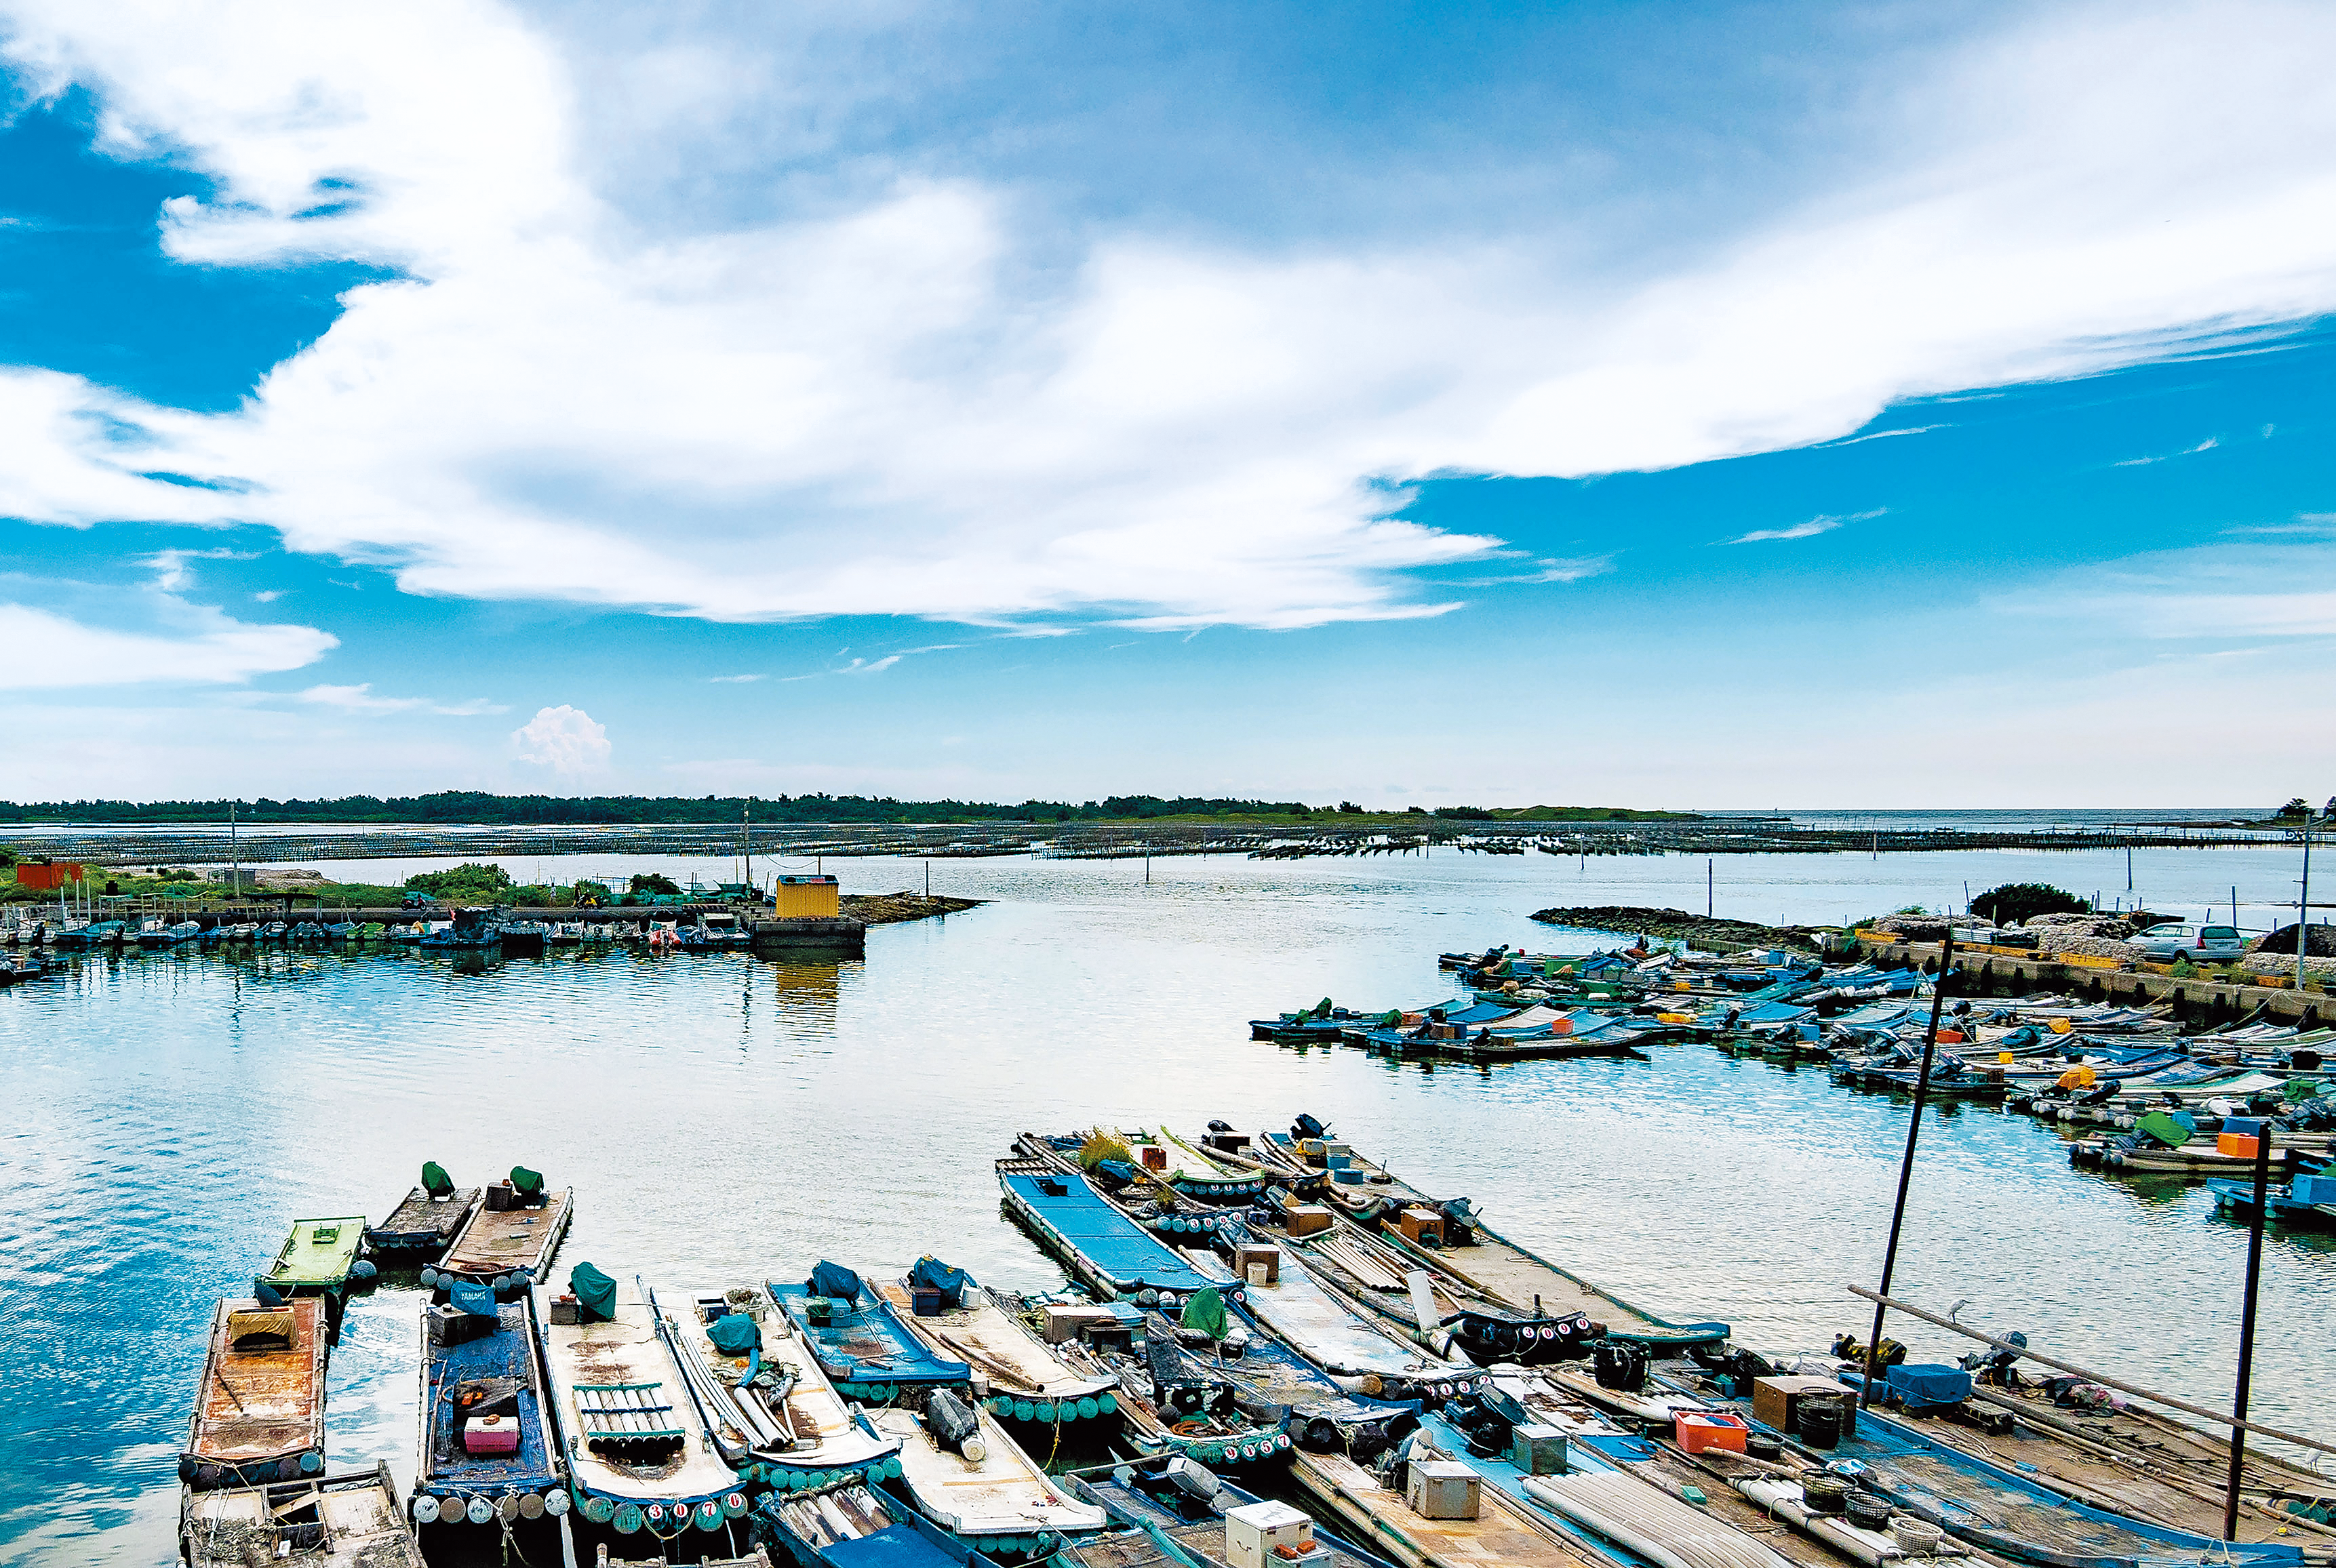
1245 1133 1728 1348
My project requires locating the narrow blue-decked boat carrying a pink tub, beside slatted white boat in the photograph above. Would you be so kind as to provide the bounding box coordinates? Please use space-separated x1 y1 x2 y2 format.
414 1283 570 1528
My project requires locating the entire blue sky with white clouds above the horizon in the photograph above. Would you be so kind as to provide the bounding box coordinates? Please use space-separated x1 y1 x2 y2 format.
0 0 2336 806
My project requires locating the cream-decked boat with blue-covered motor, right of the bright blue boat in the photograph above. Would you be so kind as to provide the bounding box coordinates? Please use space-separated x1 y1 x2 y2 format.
876 1258 1119 1439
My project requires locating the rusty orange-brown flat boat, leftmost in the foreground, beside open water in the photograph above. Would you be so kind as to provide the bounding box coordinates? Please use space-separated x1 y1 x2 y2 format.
178 1297 327 1491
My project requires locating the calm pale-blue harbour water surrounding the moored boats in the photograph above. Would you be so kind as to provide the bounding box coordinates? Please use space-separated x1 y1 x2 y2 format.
0 851 2336 1563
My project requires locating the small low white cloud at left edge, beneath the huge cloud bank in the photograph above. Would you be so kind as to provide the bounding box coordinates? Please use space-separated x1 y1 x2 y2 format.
0 596 339 689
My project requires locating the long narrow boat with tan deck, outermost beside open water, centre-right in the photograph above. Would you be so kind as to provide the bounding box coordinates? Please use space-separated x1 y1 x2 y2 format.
1227 1117 1728 1360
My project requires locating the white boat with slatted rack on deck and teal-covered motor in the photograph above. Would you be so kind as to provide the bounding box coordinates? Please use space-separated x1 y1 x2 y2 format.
535 1264 745 1540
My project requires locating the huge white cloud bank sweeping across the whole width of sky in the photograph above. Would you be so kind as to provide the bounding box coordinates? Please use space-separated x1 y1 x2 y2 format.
0 0 2336 628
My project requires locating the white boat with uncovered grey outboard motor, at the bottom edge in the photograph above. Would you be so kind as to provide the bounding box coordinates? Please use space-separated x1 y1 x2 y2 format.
869 1407 1109 1561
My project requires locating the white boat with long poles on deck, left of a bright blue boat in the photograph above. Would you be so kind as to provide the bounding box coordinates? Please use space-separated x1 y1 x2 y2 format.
652 1285 899 1493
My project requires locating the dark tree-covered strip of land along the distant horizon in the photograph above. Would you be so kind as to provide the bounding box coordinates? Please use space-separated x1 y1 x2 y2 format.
0 790 1705 827
